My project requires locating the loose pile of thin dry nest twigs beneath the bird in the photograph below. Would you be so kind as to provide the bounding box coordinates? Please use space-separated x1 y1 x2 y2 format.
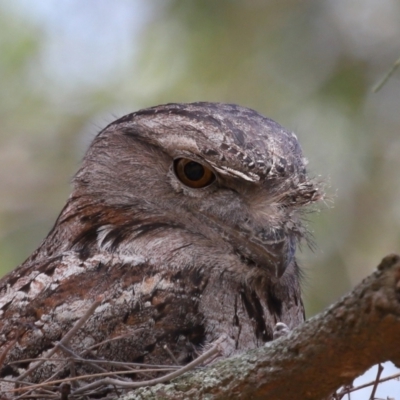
0 299 225 400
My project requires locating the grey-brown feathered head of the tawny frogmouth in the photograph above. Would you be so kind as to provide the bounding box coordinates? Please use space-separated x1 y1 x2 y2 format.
59 103 321 277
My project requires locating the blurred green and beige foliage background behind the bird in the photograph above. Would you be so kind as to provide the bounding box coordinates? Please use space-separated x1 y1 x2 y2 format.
0 0 400 315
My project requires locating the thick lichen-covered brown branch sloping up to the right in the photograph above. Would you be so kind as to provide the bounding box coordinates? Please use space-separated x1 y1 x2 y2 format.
121 255 400 400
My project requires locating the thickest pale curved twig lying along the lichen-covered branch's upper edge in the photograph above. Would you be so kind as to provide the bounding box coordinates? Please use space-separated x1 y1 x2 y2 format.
73 336 226 395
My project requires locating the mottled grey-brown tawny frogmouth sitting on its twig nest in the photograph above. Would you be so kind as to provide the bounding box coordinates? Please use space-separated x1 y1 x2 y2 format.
0 102 323 396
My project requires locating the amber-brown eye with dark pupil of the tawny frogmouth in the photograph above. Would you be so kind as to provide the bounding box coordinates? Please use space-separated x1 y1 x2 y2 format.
174 158 215 189
